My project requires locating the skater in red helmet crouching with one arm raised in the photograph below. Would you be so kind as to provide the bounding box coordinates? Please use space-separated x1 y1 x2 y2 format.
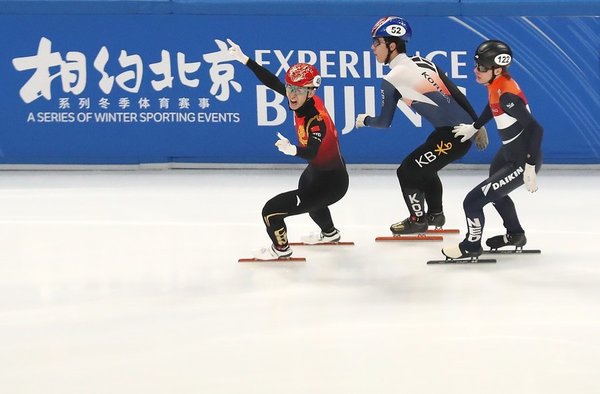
228 40 348 260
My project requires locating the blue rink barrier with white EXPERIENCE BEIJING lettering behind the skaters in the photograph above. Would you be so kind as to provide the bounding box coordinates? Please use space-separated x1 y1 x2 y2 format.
0 0 600 165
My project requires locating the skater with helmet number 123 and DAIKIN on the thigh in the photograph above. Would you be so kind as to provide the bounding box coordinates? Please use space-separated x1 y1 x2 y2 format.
442 40 543 258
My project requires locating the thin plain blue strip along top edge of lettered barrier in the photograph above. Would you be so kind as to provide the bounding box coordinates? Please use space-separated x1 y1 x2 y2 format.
0 0 600 16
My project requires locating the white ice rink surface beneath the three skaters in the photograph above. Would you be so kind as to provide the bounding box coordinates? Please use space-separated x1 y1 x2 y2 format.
0 169 600 394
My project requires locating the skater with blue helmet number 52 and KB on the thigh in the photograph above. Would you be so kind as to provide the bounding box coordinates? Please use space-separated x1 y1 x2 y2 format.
356 16 488 235
